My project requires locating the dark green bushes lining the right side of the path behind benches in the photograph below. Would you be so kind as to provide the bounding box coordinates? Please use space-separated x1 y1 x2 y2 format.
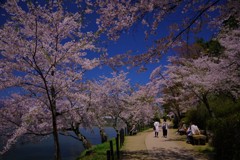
185 95 240 160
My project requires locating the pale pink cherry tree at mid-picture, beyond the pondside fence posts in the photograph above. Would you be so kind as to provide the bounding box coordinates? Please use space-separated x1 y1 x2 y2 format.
90 72 131 130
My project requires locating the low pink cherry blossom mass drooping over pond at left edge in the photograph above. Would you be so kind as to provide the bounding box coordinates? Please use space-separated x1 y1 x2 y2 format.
0 94 52 153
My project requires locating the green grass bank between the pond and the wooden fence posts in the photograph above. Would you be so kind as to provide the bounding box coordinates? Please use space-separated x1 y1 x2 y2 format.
77 139 117 160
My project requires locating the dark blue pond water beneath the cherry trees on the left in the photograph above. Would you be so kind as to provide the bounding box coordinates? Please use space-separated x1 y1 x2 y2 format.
0 127 116 160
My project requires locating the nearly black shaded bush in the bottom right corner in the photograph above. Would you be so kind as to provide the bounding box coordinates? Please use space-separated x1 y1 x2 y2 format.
208 112 240 160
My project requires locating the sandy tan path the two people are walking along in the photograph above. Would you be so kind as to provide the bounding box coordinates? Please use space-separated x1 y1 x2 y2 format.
121 129 211 160
